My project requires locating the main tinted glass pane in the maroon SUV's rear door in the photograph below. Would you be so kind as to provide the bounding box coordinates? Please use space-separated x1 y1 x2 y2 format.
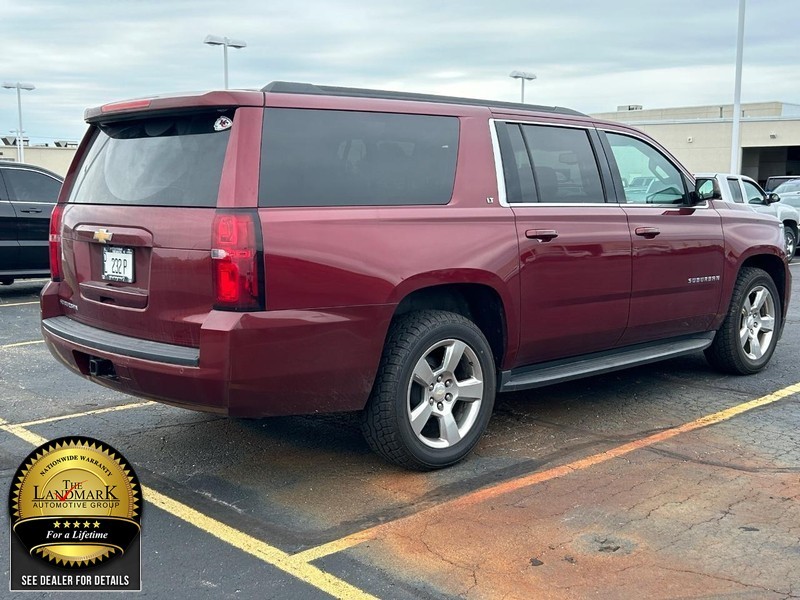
522 125 605 203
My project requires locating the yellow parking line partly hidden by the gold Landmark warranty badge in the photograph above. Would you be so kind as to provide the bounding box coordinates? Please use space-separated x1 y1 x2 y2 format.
0 419 378 600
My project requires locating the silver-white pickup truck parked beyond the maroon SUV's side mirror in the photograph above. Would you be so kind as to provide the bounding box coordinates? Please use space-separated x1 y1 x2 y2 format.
697 173 800 262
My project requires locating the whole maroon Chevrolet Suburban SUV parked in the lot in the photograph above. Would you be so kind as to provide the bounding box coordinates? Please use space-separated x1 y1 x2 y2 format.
42 82 790 469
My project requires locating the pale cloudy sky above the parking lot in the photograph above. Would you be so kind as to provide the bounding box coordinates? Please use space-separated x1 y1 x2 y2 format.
0 0 800 144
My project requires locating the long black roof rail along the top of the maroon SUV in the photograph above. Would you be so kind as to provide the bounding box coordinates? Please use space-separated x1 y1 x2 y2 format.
261 81 587 117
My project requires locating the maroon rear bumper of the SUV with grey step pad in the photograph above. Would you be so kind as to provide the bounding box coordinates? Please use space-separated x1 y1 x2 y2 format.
42 287 392 417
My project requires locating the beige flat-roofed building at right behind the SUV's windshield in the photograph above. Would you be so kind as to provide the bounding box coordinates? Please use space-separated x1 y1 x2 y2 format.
592 102 800 183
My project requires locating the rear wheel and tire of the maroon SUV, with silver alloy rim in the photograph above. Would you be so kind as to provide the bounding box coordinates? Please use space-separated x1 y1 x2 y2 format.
362 310 495 470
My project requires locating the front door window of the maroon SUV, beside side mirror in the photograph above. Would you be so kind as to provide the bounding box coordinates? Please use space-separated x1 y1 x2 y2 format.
606 133 688 204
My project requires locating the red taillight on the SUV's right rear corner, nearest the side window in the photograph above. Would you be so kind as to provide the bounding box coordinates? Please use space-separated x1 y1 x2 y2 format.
211 212 264 310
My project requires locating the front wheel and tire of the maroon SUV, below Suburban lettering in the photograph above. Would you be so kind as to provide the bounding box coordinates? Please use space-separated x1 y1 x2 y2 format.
705 267 781 375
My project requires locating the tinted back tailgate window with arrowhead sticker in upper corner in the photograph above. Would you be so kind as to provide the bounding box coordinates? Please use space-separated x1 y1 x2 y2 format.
69 112 232 206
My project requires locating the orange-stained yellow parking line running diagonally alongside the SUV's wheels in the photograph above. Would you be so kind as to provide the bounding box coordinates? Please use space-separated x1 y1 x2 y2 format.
306 383 800 560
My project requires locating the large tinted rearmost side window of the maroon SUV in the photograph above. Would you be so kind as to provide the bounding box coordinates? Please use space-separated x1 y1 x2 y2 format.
259 108 458 206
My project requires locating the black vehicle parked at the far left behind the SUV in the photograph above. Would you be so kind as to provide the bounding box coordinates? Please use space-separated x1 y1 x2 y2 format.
0 162 63 285
